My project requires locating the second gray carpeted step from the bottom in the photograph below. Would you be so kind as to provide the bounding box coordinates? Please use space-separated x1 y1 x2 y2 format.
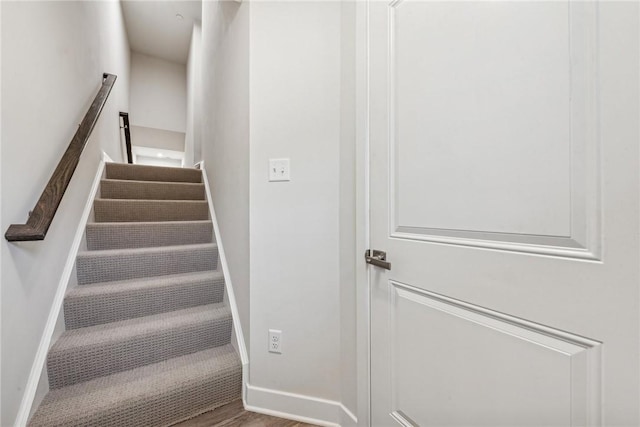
47 305 231 389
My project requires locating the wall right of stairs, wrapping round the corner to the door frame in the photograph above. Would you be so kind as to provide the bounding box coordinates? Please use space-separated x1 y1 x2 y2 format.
202 1 357 422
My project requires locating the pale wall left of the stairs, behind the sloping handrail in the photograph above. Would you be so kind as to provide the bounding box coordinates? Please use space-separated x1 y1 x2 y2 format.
0 1 129 426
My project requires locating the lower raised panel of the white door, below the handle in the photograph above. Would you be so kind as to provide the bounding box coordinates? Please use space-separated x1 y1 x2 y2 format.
387 282 601 426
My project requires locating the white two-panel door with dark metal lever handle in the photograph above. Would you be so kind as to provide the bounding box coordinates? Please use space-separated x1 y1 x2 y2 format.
367 0 640 427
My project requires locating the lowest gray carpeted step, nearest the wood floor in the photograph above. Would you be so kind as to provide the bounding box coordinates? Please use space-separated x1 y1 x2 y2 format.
29 344 242 427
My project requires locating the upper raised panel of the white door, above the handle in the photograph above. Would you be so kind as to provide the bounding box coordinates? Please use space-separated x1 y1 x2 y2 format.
388 0 599 258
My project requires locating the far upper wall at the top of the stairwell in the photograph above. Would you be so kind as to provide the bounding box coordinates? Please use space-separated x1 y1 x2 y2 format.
129 52 187 135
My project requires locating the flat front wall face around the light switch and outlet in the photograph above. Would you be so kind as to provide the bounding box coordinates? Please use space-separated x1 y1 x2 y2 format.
250 1 341 411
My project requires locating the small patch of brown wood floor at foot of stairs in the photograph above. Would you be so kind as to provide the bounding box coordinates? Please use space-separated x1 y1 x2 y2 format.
173 400 314 427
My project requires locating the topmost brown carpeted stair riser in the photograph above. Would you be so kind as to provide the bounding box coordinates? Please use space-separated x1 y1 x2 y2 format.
106 163 202 182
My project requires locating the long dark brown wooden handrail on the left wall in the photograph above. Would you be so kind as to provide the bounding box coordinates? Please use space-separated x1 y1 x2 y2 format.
4 73 117 242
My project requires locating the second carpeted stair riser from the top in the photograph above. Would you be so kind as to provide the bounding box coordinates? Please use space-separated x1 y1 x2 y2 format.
100 180 204 200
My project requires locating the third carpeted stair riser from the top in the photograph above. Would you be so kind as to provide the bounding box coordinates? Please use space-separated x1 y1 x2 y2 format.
93 199 209 222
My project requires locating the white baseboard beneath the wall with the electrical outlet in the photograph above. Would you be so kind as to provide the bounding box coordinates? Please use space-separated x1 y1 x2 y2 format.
245 384 358 427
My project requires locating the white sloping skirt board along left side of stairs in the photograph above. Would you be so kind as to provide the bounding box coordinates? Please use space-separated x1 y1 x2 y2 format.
14 152 111 427
